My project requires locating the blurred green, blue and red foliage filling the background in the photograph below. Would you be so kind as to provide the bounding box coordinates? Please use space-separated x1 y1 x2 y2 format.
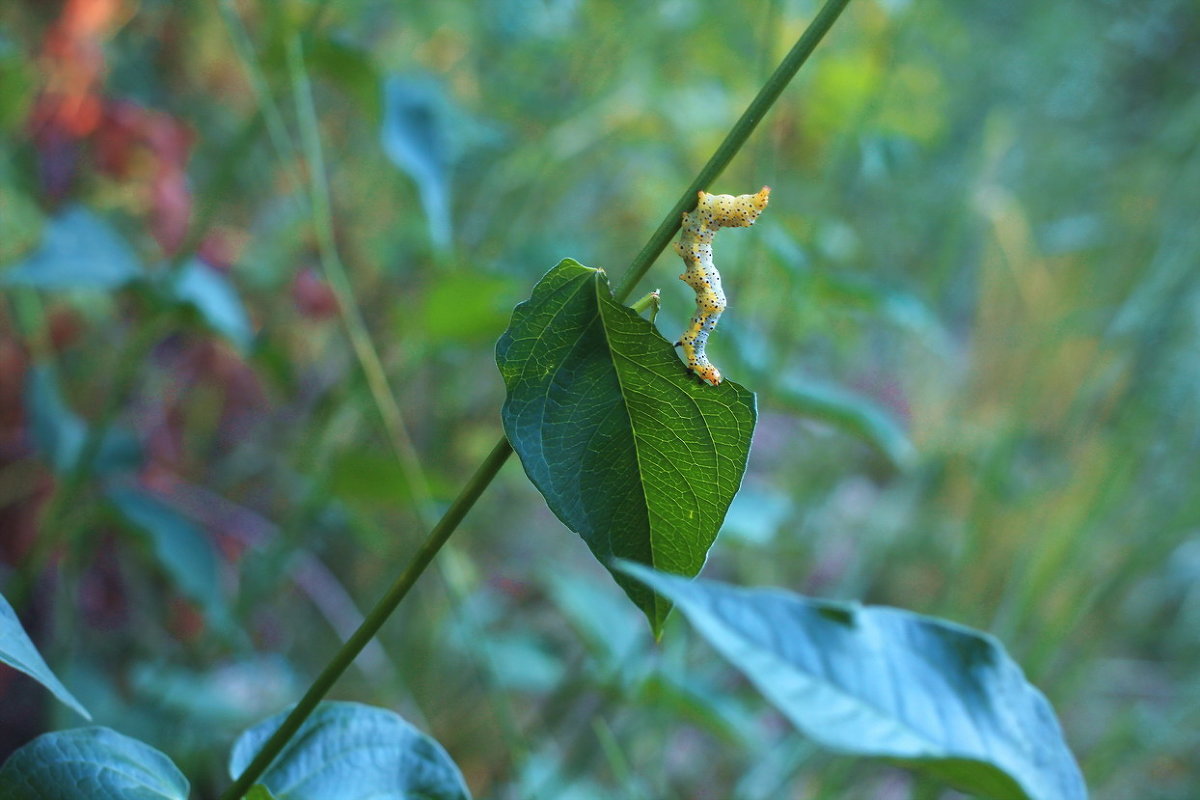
0 0 1200 800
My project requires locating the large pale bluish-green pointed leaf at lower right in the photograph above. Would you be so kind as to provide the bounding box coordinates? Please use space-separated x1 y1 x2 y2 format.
620 563 1087 800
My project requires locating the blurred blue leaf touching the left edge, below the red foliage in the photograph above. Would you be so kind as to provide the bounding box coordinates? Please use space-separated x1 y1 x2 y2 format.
0 206 143 290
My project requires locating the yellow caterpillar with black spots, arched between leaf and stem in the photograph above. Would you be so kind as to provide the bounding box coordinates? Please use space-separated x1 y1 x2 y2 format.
674 186 770 386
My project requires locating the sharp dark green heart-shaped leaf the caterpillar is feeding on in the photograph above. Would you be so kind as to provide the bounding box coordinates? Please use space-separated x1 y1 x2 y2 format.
496 259 756 633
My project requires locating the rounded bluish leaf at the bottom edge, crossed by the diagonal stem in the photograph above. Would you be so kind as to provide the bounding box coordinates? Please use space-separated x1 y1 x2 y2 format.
229 703 470 800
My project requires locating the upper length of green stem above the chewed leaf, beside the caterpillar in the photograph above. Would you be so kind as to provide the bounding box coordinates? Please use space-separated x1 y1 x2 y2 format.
613 0 850 302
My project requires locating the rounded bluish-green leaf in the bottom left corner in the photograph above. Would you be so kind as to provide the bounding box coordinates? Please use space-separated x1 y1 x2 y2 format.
0 728 188 800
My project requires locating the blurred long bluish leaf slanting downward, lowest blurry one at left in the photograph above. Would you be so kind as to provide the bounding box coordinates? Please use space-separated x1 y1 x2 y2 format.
108 486 224 622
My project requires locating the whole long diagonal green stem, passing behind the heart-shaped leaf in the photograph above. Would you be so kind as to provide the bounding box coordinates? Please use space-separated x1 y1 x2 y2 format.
220 0 850 800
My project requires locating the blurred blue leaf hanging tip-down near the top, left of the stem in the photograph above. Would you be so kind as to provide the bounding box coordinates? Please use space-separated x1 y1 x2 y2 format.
379 77 452 247
